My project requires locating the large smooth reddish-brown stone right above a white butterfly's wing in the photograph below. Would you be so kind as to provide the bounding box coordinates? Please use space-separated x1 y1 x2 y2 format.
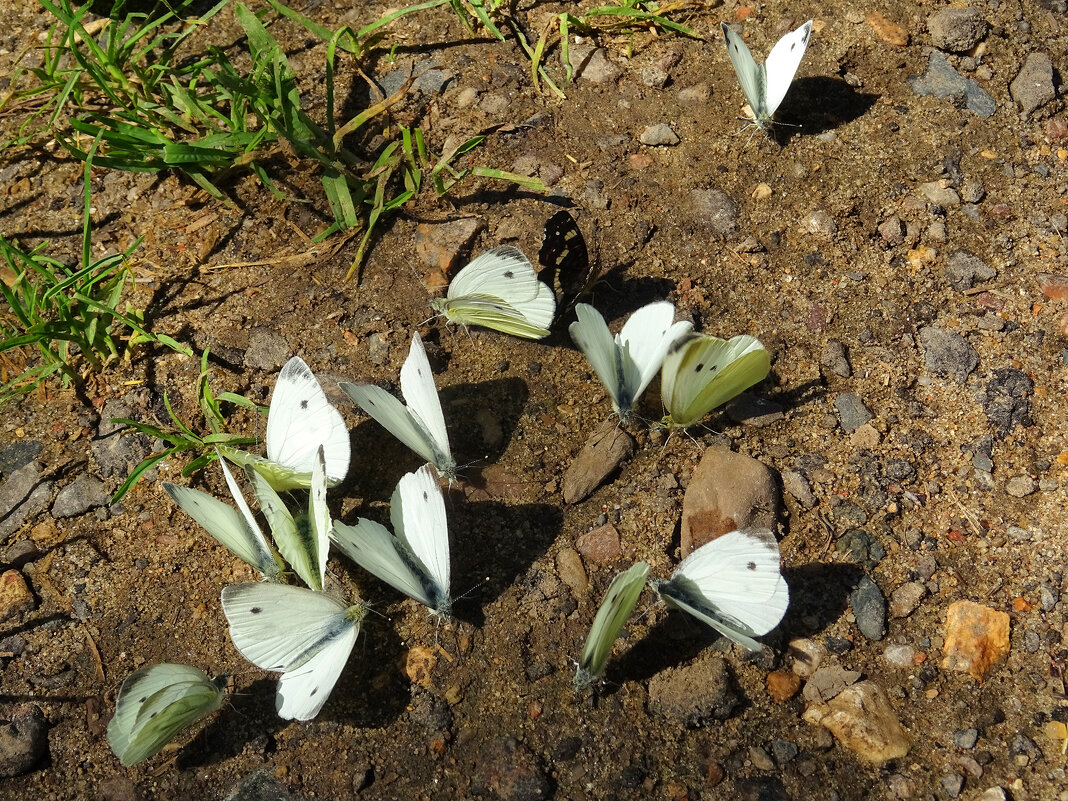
680 447 783 559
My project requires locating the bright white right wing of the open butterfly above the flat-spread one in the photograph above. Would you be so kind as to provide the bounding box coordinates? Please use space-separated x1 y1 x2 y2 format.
390 465 452 617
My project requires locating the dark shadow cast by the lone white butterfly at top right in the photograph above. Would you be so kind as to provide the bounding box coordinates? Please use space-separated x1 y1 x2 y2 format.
771 76 879 146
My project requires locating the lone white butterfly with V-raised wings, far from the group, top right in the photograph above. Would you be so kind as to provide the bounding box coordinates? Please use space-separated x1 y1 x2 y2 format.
720 19 812 130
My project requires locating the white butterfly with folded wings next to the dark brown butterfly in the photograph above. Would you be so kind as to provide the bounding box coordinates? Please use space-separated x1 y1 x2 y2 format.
430 246 556 340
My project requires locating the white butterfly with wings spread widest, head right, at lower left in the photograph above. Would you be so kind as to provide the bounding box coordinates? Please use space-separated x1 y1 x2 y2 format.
222 583 366 720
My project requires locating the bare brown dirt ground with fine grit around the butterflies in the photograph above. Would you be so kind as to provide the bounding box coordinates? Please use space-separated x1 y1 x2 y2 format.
0 0 1068 801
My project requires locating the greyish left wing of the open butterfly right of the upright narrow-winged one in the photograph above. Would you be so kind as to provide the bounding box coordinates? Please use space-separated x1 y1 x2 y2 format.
331 518 435 609
